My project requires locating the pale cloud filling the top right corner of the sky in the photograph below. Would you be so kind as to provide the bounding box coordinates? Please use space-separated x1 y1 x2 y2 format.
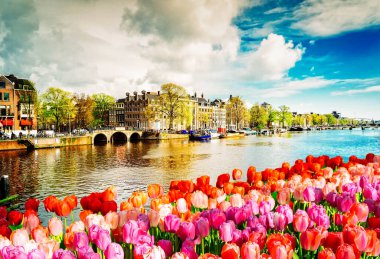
292 0 380 37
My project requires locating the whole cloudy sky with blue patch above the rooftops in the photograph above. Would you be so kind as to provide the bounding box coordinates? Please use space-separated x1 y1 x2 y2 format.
0 0 380 119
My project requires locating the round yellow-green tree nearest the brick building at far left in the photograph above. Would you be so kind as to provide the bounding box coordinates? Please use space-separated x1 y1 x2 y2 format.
40 87 75 130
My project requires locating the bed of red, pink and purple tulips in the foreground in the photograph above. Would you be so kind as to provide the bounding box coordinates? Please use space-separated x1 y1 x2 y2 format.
0 154 380 259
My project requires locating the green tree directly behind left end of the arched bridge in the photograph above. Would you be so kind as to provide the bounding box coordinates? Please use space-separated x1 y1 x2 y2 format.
92 93 116 126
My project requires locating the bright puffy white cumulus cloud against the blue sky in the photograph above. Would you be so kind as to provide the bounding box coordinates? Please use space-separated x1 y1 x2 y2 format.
242 33 305 80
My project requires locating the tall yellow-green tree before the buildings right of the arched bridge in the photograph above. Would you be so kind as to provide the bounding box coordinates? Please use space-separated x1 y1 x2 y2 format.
157 83 187 129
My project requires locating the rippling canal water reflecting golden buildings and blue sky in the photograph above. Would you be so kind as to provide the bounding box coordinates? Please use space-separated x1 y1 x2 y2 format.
0 130 380 221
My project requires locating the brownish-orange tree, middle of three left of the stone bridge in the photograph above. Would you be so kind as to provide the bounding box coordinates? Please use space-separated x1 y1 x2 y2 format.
74 94 95 128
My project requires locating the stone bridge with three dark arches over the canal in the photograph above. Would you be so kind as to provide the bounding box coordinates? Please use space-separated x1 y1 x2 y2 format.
91 130 143 144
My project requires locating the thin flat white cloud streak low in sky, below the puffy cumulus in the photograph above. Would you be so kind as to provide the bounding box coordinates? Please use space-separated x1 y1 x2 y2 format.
262 77 337 97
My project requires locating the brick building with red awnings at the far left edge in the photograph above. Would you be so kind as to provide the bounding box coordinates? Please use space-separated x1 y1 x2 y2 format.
0 75 37 131
